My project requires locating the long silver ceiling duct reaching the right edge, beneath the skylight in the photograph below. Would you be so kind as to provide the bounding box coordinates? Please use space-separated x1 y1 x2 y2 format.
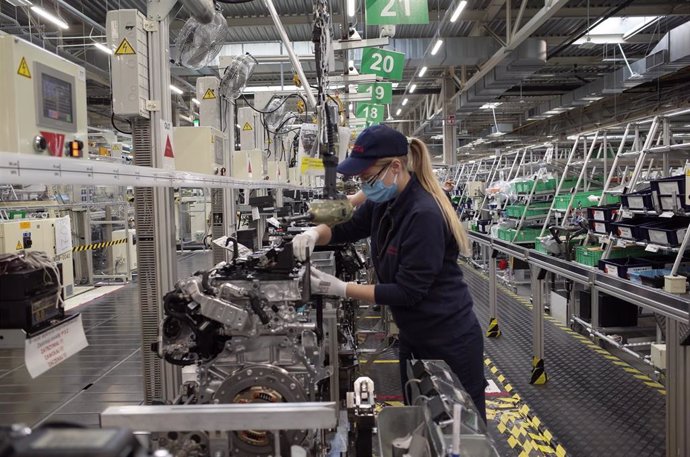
527 22 690 120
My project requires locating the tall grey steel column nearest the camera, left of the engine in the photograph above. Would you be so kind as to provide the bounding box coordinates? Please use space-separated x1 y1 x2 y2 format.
133 8 181 404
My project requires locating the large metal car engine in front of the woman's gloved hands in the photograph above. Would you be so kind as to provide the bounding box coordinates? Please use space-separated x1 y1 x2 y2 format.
157 244 338 456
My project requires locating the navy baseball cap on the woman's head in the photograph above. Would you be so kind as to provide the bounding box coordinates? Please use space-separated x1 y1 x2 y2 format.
337 124 407 176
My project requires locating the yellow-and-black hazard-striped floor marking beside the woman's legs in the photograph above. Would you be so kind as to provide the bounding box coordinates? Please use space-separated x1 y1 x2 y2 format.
484 357 567 457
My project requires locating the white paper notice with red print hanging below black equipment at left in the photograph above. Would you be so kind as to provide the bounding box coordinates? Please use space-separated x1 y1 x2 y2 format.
24 315 89 378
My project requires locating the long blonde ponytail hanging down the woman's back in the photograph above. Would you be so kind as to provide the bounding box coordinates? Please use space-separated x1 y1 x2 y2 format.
408 138 470 256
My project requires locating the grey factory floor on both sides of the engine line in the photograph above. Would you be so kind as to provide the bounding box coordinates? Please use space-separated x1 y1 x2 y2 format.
0 252 665 457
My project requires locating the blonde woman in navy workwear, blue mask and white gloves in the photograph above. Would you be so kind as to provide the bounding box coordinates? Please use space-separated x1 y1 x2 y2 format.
293 125 486 420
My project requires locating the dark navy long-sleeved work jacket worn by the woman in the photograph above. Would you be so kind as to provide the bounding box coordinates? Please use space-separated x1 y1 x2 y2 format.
331 175 478 344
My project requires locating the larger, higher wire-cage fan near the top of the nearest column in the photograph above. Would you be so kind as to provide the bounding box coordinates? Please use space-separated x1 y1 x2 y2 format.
176 11 228 70
